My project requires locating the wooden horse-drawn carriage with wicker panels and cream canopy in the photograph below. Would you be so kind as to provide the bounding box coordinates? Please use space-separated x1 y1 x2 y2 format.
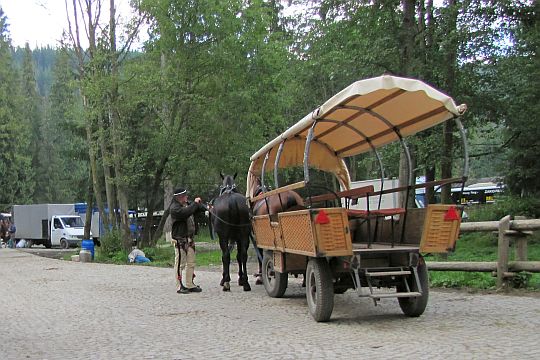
247 76 468 321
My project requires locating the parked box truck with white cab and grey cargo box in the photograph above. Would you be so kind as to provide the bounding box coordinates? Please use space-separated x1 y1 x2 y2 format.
12 204 90 249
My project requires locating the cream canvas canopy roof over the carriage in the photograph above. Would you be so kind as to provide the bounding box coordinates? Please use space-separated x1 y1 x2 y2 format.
248 75 467 196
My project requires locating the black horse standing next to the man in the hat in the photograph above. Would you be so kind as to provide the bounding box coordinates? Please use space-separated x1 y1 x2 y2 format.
210 174 251 291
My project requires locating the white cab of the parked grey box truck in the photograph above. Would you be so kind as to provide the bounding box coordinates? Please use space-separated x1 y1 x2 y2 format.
50 215 84 249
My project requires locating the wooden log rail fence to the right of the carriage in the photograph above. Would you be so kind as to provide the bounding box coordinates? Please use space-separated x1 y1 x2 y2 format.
428 215 540 288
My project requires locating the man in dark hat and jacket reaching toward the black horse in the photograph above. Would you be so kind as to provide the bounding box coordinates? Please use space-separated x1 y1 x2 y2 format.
170 188 205 294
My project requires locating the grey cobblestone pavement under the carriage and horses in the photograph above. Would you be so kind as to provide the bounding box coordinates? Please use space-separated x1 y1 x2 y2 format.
0 249 540 359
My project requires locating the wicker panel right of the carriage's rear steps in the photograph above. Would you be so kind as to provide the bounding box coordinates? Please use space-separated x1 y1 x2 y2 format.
420 205 461 253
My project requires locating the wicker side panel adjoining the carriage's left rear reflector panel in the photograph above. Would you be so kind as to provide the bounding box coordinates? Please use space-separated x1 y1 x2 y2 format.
279 210 315 256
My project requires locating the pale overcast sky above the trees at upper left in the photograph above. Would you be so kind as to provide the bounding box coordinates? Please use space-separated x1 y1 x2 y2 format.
0 0 137 49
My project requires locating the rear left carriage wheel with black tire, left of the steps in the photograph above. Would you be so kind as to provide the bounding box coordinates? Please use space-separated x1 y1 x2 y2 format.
306 258 334 322
